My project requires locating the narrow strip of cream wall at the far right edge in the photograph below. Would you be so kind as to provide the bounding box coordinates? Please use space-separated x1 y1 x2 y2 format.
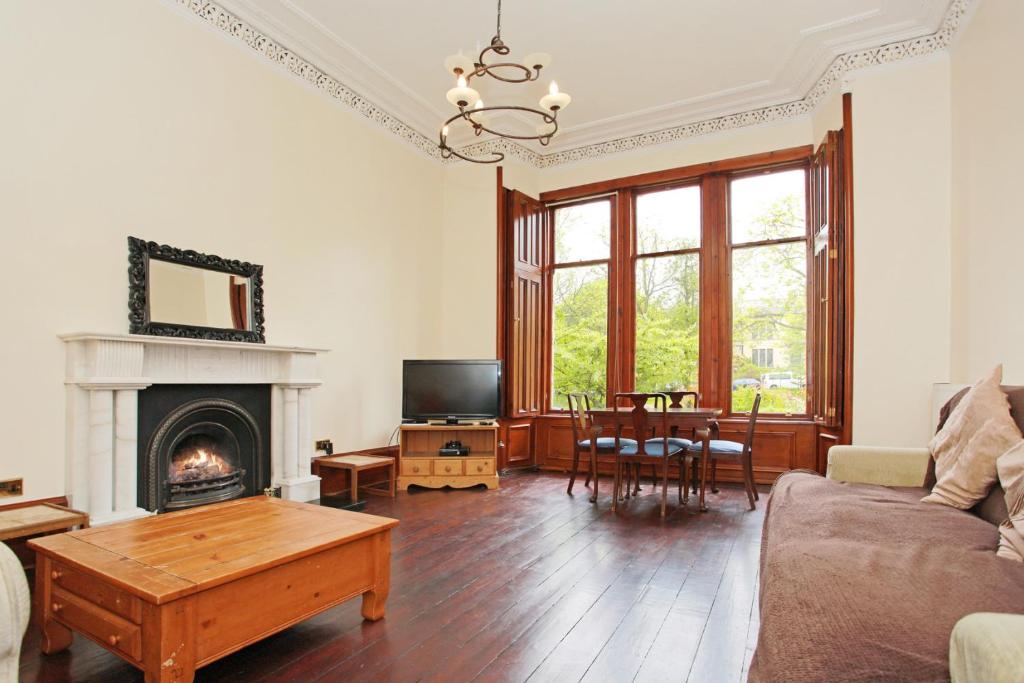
952 0 1024 384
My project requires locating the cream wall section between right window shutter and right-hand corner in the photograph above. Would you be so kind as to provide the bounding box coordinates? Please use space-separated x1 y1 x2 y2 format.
851 53 952 446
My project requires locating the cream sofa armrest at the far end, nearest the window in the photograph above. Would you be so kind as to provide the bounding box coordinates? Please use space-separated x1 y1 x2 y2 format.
825 445 932 486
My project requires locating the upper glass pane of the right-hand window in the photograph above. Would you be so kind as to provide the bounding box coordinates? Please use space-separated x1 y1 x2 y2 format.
729 169 807 245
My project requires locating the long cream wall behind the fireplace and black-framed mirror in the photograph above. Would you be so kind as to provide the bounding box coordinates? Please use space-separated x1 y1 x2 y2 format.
0 0 446 503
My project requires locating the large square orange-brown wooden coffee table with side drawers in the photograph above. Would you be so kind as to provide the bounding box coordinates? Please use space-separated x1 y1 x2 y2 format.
29 497 398 682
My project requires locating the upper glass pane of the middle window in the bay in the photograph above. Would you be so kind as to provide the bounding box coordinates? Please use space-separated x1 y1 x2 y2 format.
637 186 700 254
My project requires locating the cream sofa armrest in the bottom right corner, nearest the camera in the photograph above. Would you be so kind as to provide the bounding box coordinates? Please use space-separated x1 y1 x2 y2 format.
949 612 1024 683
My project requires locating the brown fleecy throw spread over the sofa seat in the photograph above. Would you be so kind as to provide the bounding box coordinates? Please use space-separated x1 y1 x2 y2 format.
749 473 1024 683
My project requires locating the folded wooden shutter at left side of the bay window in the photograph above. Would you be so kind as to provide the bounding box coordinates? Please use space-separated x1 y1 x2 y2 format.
505 190 550 417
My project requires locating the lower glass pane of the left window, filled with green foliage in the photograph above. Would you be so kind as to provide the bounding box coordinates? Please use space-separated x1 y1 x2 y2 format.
551 265 608 408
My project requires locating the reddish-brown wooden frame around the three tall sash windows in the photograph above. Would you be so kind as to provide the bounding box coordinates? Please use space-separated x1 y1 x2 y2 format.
540 145 814 422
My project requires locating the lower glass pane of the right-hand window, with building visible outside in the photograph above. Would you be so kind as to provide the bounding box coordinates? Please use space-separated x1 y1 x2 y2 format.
732 242 807 414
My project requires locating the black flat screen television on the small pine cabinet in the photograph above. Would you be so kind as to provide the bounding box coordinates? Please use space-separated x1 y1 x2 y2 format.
401 360 502 421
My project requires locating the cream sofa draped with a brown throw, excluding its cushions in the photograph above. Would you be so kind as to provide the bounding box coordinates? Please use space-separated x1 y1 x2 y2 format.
749 387 1024 683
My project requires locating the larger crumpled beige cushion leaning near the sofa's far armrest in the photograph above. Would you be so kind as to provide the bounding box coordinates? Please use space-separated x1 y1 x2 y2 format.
923 366 1021 510
